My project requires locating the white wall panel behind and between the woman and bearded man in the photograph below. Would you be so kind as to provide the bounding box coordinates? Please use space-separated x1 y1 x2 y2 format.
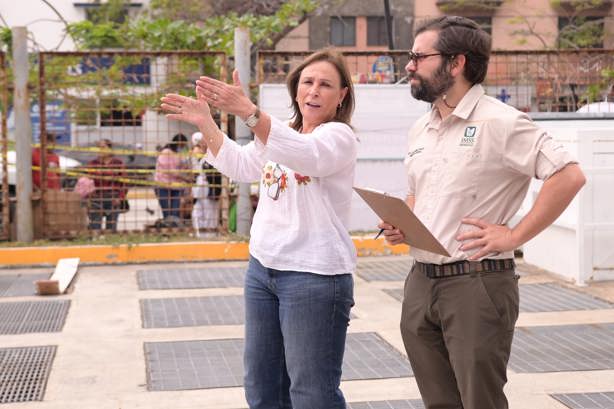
259 84 429 231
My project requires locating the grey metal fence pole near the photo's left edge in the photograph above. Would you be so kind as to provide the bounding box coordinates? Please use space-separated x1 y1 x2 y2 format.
12 27 34 242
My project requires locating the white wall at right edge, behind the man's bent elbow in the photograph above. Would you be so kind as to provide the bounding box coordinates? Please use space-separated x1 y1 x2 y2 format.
517 119 614 285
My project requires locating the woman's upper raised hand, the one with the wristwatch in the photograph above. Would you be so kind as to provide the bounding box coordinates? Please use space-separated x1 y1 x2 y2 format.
196 70 256 119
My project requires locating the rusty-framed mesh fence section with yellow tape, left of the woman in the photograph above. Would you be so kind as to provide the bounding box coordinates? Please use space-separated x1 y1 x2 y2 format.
33 52 229 238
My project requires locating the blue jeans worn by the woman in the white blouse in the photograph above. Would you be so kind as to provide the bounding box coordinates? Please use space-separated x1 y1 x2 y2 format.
244 253 354 409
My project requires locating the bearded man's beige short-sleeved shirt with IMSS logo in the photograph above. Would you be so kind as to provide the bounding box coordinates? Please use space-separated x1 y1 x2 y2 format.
405 84 575 264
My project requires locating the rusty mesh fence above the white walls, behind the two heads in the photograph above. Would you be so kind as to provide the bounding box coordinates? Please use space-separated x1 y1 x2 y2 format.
258 50 614 112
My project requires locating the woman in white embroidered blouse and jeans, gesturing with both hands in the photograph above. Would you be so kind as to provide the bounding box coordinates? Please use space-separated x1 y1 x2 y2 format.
162 50 358 409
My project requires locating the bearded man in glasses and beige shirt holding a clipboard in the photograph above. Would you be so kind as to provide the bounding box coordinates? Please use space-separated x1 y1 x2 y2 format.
380 17 585 409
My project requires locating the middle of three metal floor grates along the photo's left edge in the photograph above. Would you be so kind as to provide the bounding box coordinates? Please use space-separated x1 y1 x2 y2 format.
0 300 70 335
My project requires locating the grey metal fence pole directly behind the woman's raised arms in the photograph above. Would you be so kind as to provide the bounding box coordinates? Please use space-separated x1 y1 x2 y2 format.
234 27 252 236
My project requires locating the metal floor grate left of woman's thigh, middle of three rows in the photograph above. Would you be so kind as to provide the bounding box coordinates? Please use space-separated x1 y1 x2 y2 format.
141 295 245 328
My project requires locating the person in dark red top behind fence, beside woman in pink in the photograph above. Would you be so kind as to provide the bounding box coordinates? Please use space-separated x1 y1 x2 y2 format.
88 139 127 232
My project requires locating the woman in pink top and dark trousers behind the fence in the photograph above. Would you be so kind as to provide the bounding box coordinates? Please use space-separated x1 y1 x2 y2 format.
154 133 191 223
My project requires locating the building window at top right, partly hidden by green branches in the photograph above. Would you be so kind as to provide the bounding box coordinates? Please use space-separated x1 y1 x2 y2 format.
557 16 604 48
